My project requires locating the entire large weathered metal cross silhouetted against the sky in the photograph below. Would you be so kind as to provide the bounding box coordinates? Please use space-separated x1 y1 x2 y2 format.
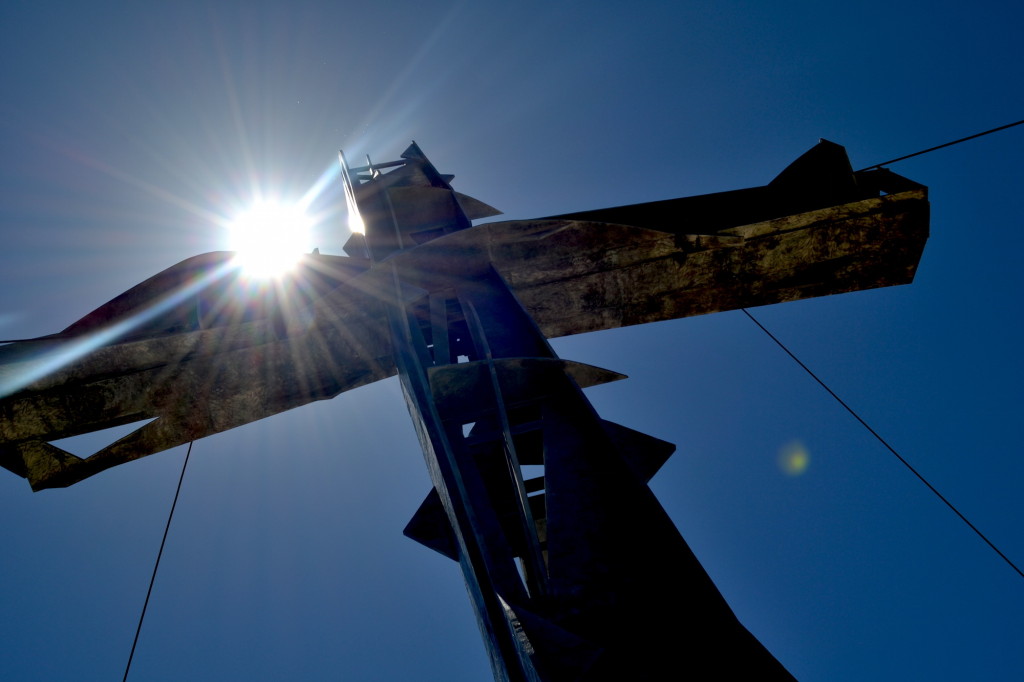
0 141 929 682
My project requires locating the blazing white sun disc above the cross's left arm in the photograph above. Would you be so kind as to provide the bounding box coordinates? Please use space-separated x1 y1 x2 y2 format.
229 202 311 278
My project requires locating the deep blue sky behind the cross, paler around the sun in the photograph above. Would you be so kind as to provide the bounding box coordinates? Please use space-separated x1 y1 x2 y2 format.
0 0 1024 682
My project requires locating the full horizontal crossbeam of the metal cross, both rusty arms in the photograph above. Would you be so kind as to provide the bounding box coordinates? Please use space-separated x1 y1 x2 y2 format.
0 145 928 489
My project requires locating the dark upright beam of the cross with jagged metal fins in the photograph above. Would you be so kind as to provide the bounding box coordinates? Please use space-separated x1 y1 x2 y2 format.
342 143 792 682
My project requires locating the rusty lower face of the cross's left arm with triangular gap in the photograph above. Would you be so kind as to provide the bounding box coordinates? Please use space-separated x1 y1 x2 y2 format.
0 251 394 489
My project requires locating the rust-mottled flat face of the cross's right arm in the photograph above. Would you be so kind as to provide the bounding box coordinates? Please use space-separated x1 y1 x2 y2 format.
408 183 928 338
